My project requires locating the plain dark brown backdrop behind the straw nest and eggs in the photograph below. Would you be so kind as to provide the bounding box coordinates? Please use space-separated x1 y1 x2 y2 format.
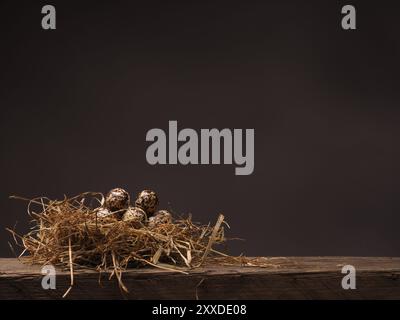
0 0 400 256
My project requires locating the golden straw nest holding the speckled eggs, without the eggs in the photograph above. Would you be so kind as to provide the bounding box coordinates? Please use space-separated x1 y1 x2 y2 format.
8 192 227 295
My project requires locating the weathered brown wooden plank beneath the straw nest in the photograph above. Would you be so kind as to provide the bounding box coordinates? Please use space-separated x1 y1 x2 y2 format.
0 257 400 299
